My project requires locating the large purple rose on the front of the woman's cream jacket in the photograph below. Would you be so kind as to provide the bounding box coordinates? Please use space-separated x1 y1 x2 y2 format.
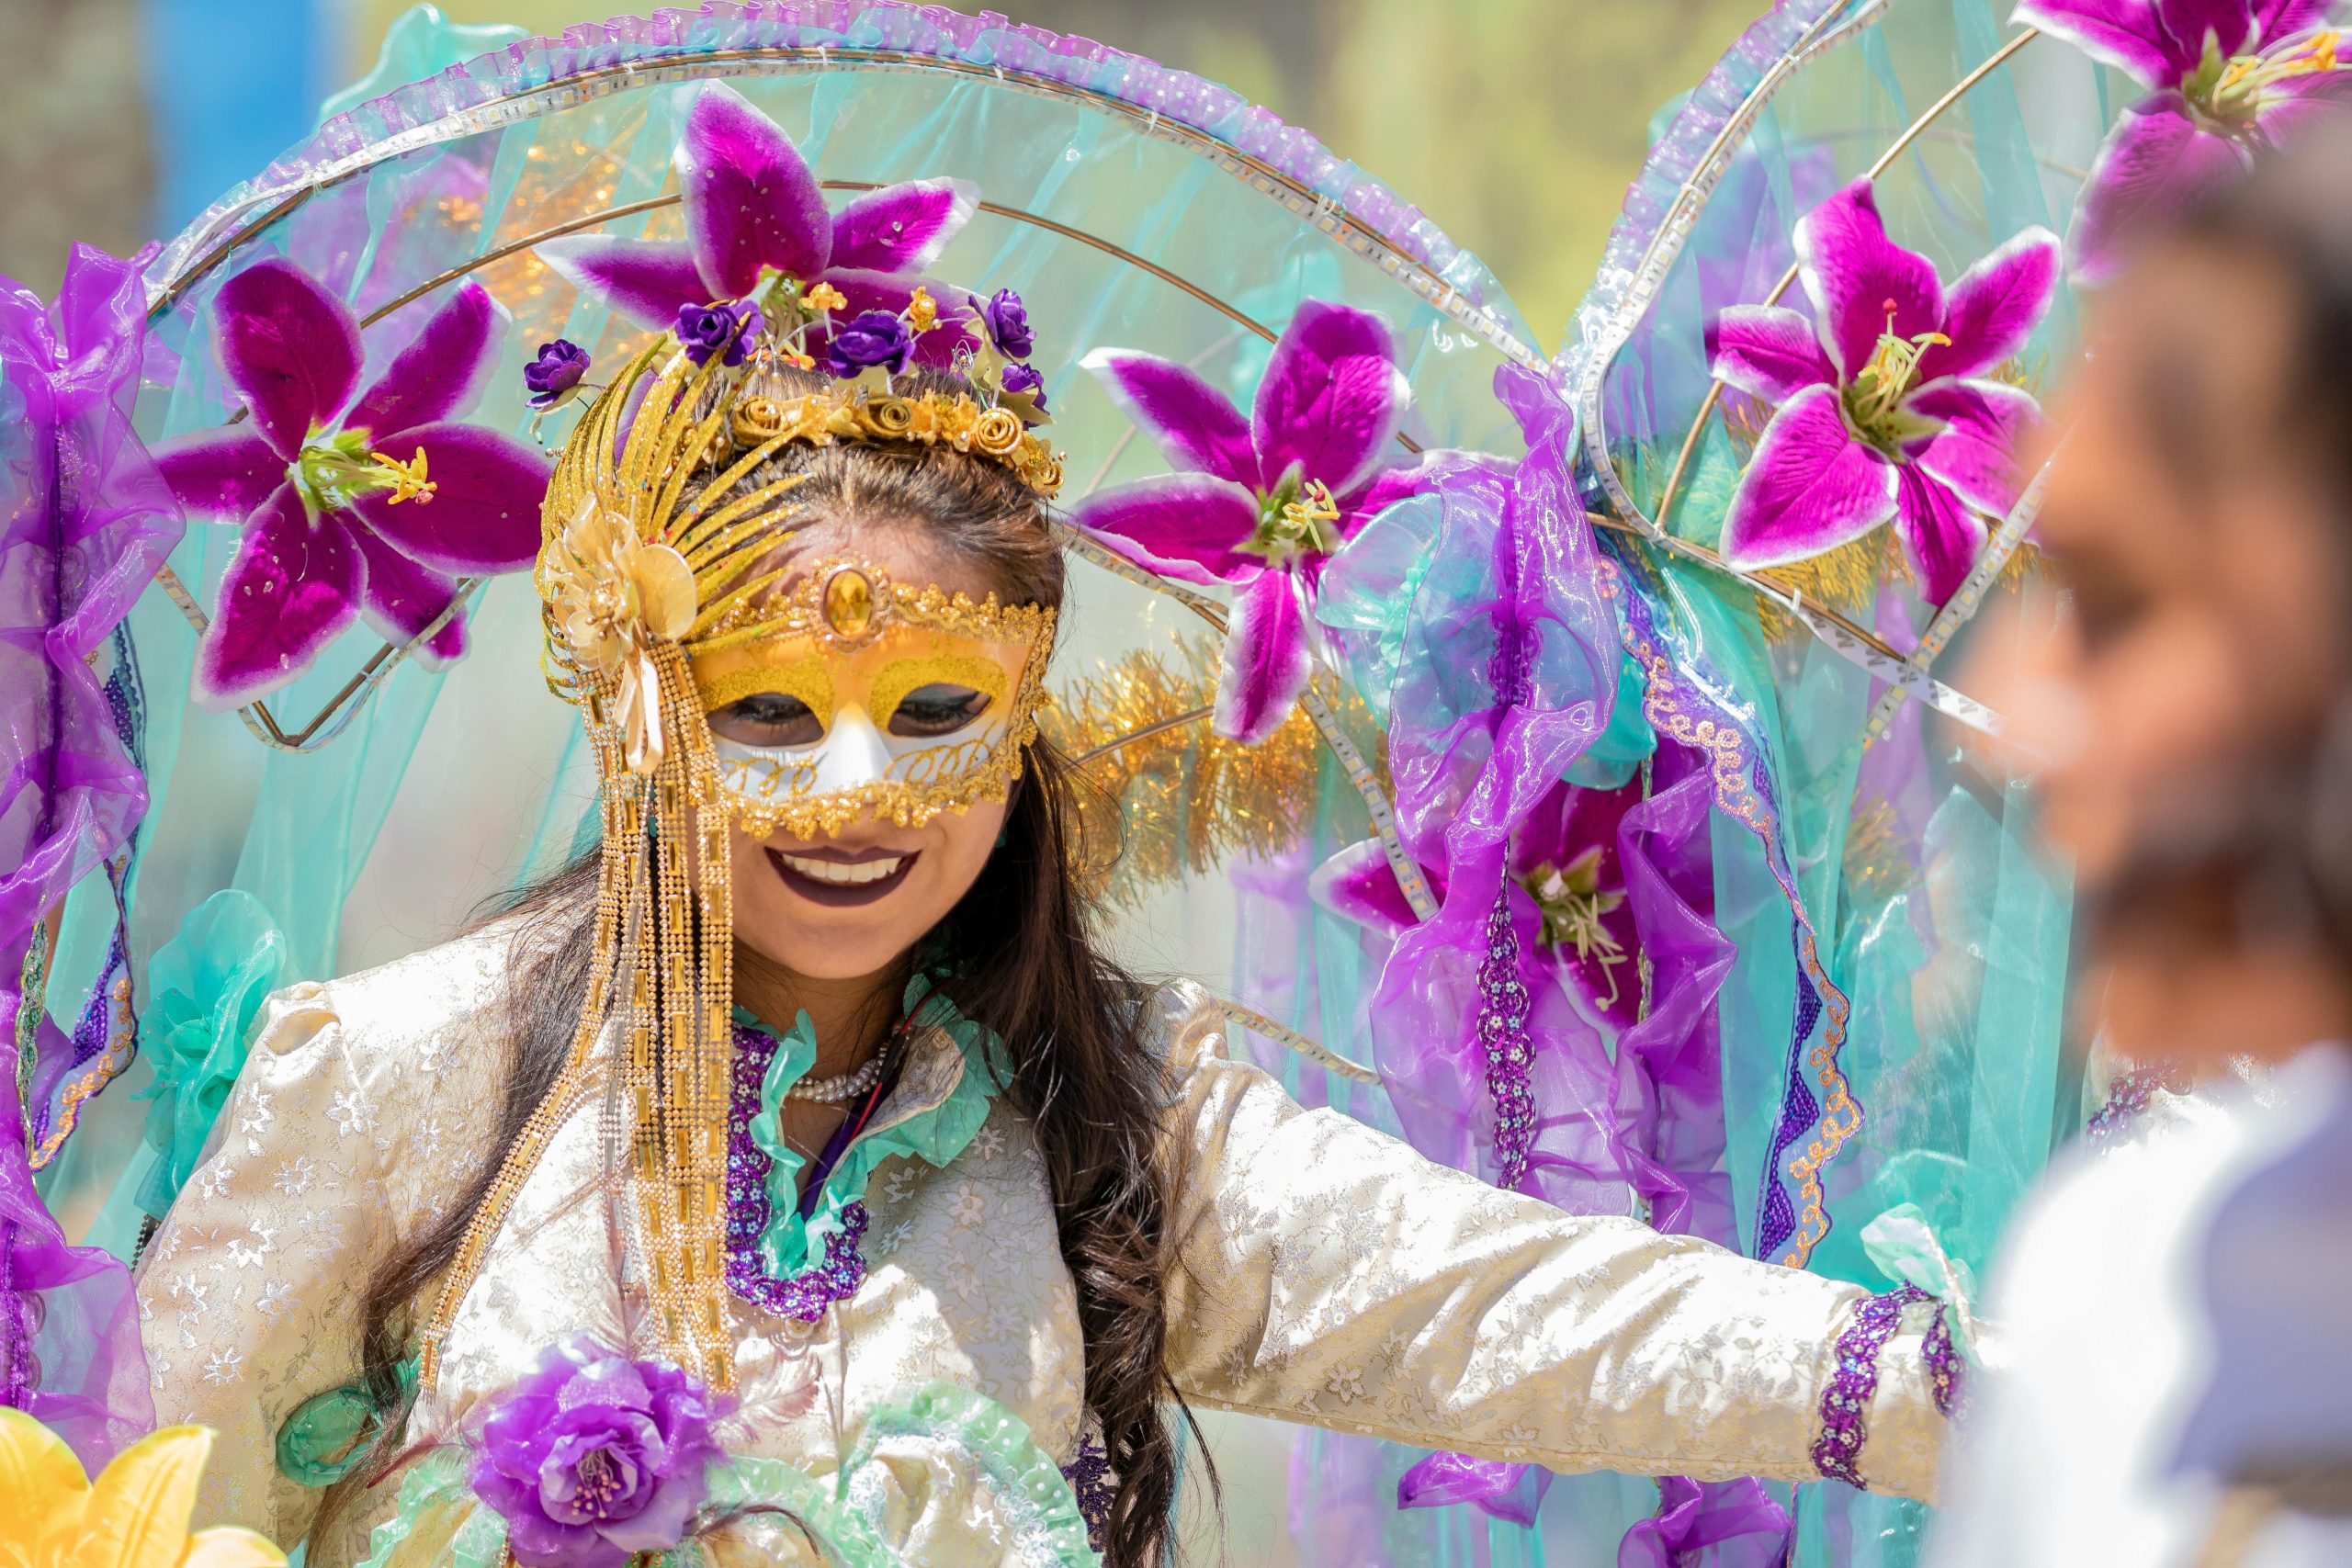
468 1340 719 1568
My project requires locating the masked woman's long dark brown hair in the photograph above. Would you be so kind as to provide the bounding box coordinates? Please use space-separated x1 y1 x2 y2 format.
360 364 1190 1568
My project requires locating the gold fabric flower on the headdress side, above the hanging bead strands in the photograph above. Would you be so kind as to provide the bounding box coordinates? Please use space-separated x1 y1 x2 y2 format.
546 501 694 773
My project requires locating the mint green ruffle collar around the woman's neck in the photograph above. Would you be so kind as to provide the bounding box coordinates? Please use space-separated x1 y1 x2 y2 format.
734 974 1012 1279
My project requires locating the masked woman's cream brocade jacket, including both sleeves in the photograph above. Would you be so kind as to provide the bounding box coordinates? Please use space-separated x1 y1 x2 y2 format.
139 936 1943 1568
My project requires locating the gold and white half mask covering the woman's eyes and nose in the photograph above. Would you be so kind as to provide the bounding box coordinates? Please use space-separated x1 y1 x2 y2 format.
687 559 1054 837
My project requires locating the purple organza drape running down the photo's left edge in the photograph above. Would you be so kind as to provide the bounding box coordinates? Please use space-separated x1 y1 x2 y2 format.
0 247 181 1470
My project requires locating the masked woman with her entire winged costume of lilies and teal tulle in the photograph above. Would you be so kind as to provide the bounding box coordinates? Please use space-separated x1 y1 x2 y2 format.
0 0 2340 1563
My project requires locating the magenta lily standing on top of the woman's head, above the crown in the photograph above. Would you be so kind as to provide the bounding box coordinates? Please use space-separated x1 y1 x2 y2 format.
537 83 978 365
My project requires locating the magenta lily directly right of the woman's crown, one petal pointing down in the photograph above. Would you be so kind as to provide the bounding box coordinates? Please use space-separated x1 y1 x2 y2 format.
1072 299 1425 743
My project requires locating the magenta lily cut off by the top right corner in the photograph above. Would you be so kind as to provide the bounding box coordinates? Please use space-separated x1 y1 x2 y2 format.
2011 0 2352 282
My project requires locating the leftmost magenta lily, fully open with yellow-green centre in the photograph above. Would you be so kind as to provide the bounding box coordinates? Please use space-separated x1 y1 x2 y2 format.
155 256 550 710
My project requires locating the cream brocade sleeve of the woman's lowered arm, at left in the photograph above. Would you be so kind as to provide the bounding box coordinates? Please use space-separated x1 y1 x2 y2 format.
136 950 501 1547
